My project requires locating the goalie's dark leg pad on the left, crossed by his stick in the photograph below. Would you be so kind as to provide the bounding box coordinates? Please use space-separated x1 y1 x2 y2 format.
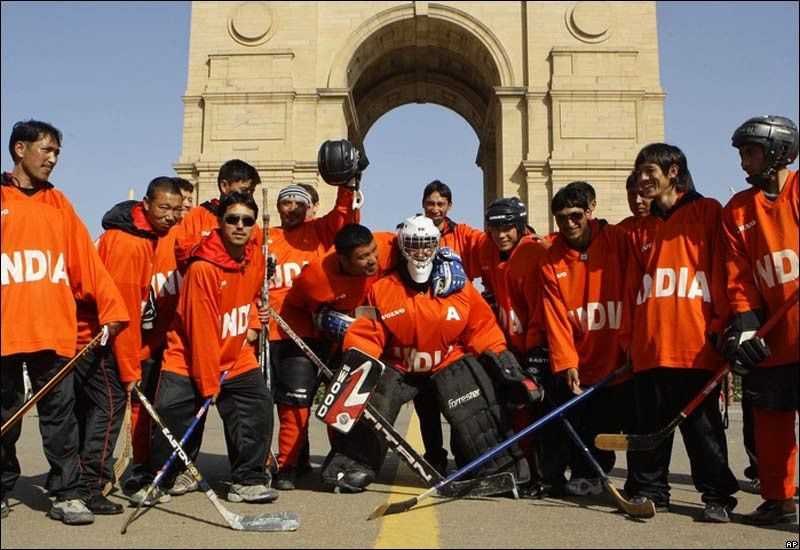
322 365 416 490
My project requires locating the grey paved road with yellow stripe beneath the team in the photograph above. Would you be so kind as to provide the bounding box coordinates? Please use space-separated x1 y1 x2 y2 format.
0 404 798 548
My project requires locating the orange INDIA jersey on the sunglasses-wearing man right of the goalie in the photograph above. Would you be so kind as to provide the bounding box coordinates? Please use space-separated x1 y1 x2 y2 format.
541 219 628 386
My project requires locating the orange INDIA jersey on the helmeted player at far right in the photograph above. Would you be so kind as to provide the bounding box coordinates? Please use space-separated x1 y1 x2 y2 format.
722 172 800 367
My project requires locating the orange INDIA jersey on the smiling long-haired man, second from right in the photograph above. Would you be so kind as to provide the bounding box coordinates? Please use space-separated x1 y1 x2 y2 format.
621 191 729 372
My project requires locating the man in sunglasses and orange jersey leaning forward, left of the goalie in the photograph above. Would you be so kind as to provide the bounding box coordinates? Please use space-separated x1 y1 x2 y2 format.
131 191 278 506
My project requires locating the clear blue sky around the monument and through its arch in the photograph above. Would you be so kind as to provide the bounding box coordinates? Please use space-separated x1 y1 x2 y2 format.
0 2 799 237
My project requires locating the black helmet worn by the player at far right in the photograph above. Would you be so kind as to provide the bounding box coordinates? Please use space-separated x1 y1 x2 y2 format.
731 115 798 184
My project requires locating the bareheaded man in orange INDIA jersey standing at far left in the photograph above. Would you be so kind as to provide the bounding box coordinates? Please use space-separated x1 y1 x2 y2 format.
0 120 129 525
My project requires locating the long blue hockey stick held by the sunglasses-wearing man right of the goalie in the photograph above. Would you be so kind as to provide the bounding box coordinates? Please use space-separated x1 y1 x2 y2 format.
367 365 630 519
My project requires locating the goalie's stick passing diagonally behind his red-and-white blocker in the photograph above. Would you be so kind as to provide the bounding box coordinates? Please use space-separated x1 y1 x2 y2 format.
270 309 516 498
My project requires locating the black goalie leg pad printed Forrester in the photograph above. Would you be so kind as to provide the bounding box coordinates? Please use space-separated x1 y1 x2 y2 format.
431 354 530 483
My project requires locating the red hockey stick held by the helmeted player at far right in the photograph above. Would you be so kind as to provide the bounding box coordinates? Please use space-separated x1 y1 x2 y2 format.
594 290 798 451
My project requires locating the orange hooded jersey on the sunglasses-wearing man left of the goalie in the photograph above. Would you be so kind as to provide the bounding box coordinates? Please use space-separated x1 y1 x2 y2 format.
161 231 265 397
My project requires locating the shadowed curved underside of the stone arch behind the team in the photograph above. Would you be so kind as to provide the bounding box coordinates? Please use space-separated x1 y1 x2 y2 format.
347 16 501 210
